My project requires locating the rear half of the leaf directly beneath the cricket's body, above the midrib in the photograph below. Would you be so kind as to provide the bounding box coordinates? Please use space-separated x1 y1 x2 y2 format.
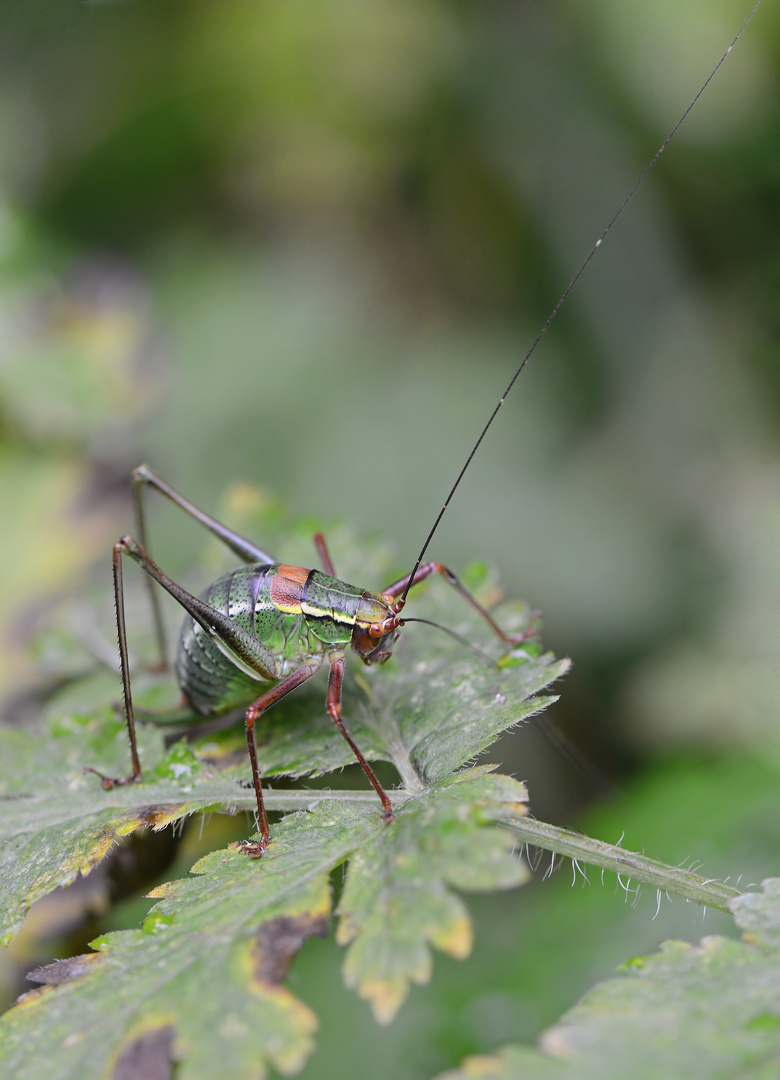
0 544 567 942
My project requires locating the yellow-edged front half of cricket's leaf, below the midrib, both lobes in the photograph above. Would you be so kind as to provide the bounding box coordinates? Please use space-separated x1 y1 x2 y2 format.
0 770 527 1080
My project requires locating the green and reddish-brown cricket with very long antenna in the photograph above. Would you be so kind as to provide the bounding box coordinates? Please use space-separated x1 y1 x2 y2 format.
86 0 761 858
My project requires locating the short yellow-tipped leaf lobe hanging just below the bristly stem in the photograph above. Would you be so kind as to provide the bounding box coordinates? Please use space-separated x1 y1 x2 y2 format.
336 769 528 1024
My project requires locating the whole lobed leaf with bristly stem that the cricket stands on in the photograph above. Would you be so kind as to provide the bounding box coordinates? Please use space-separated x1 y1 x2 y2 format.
0 518 749 1080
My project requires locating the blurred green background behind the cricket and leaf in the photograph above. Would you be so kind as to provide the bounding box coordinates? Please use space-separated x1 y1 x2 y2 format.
0 0 780 1078
